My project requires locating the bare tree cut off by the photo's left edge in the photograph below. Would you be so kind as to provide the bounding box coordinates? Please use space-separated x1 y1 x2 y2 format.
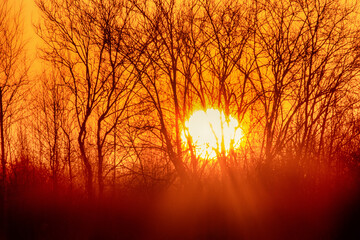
0 0 28 208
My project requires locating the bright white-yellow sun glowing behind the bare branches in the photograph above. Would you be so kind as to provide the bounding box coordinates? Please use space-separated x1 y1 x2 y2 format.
182 108 243 159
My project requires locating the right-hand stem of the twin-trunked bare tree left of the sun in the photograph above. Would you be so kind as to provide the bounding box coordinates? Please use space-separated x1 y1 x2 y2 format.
93 1 136 195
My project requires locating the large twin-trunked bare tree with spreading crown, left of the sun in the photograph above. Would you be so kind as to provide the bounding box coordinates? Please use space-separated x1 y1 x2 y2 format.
38 0 135 196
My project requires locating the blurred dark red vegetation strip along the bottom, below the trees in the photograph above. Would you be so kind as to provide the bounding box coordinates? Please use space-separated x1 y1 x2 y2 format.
1 160 360 239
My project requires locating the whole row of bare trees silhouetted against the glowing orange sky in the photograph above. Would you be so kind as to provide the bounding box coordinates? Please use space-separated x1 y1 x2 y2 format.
0 0 360 197
